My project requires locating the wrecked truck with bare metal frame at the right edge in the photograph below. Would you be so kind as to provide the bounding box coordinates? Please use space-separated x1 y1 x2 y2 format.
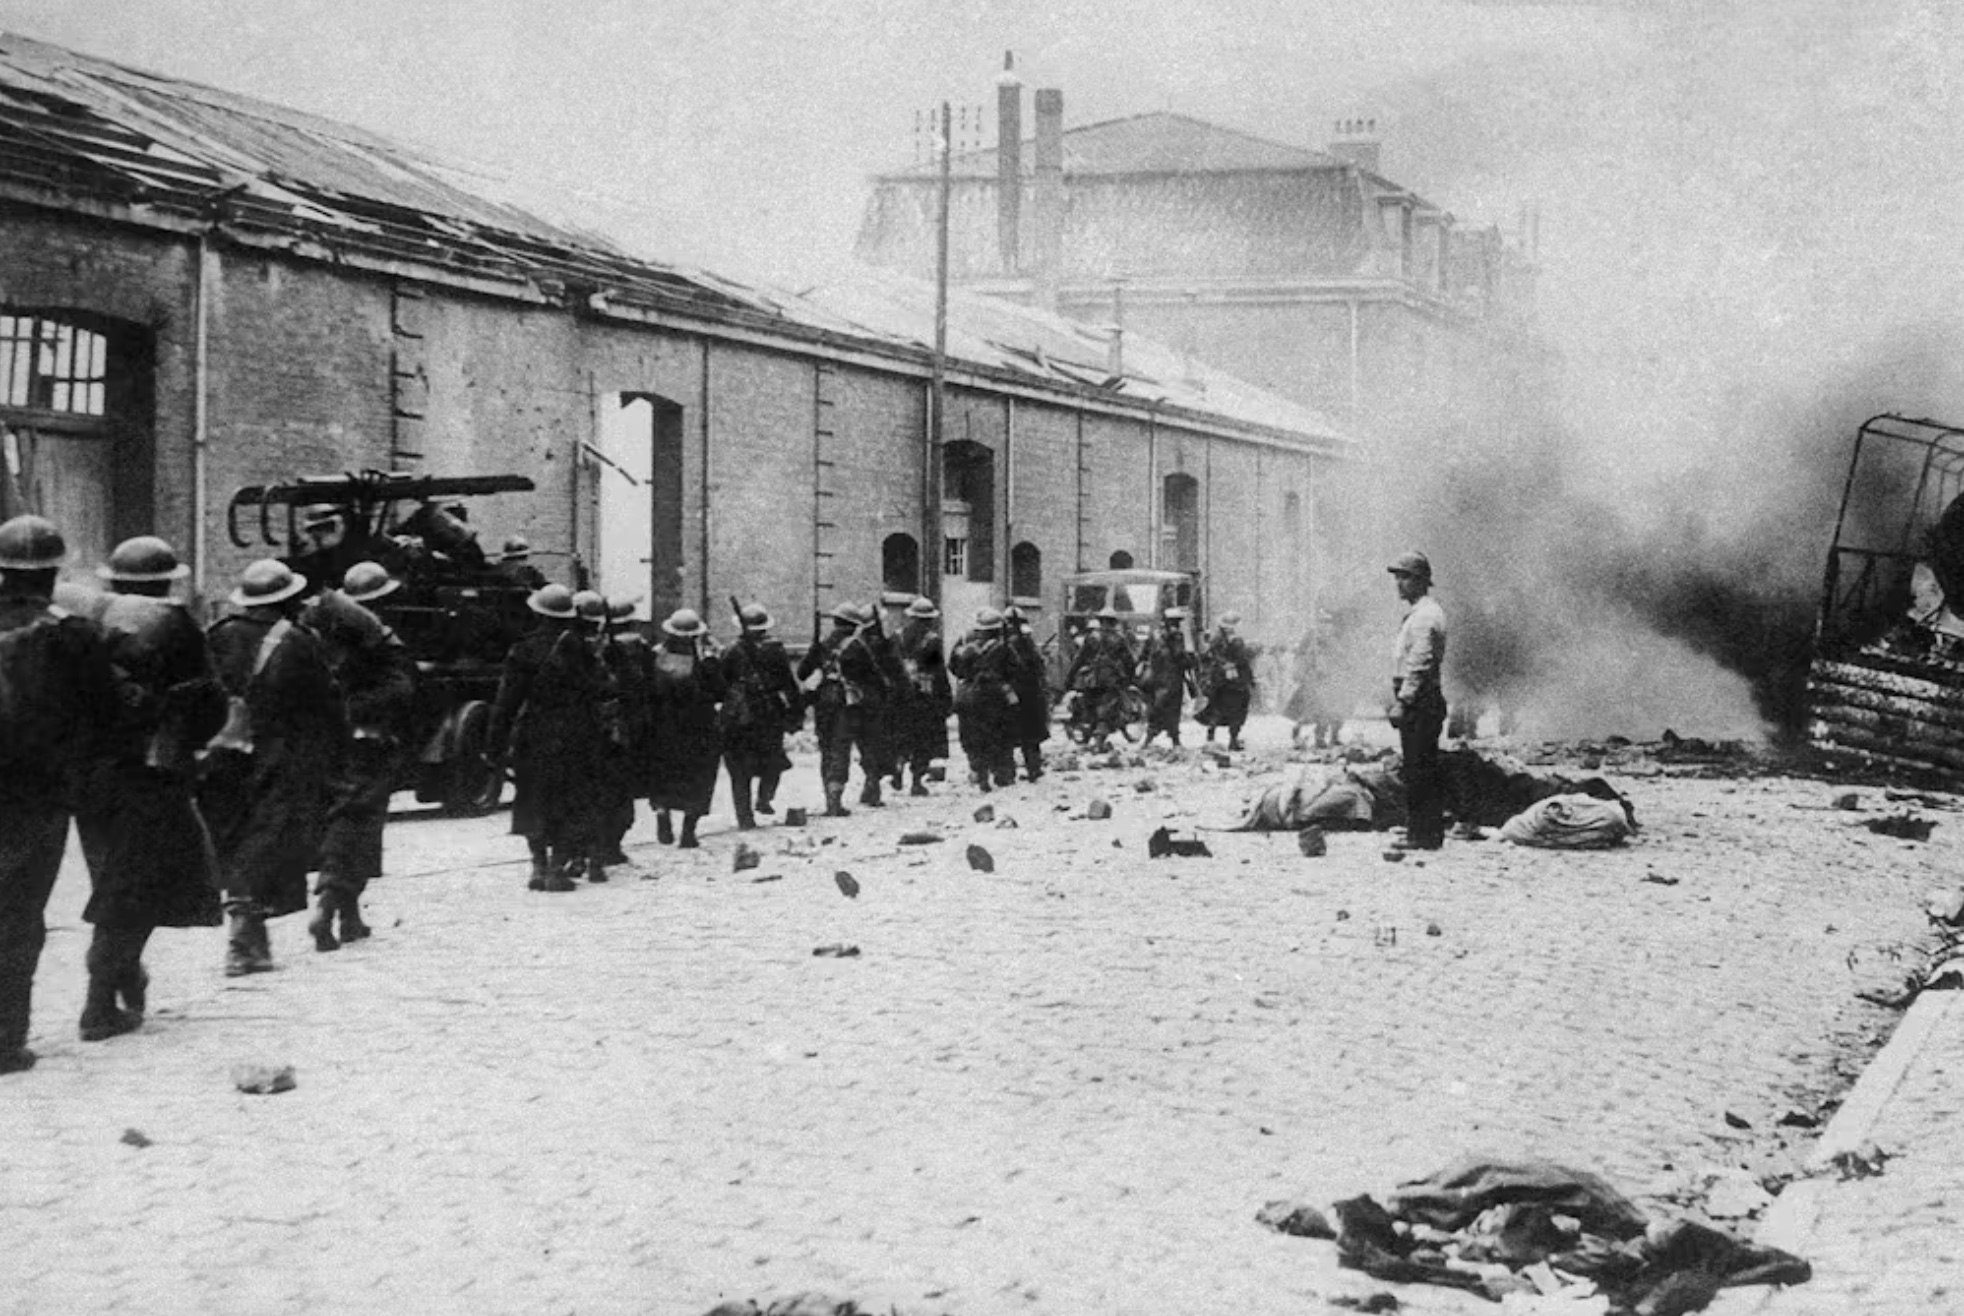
1807 414 1964 776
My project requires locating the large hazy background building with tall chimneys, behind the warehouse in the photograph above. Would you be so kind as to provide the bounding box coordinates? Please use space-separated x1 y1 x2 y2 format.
858 75 1542 436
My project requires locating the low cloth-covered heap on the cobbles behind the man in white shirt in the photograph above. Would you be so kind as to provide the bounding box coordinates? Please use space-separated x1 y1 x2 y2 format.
1228 746 1636 849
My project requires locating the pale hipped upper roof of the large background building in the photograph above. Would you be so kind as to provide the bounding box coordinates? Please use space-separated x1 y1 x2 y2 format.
886 110 1347 179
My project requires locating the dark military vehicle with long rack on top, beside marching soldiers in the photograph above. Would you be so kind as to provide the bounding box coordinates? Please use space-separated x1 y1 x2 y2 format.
226 471 534 813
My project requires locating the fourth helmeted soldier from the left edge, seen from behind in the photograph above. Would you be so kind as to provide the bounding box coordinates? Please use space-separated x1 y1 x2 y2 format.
300 562 416 951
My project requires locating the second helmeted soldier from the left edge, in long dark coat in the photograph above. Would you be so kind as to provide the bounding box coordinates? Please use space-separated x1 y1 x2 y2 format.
75 534 226 1041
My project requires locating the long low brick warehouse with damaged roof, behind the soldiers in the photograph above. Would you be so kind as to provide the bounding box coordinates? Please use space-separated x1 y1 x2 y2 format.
0 35 1349 636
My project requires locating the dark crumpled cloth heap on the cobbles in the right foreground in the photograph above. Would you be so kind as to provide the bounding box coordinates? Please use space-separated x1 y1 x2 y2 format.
1336 1159 1813 1314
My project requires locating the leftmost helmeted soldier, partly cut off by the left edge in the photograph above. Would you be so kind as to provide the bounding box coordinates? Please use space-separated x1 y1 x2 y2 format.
0 517 118 1074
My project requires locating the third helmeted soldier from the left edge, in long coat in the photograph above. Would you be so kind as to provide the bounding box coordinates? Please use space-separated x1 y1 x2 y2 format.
198 558 348 978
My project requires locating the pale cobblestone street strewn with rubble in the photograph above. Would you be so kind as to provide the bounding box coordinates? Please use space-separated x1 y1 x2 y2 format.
0 727 1964 1314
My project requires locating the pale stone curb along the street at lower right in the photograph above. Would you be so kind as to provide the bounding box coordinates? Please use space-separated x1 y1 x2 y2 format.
1705 992 1964 1316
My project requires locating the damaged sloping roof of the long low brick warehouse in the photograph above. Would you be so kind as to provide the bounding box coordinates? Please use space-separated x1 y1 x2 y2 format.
0 33 1347 446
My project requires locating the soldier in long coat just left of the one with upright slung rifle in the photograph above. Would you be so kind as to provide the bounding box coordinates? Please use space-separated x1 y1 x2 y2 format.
648 607 729 850
